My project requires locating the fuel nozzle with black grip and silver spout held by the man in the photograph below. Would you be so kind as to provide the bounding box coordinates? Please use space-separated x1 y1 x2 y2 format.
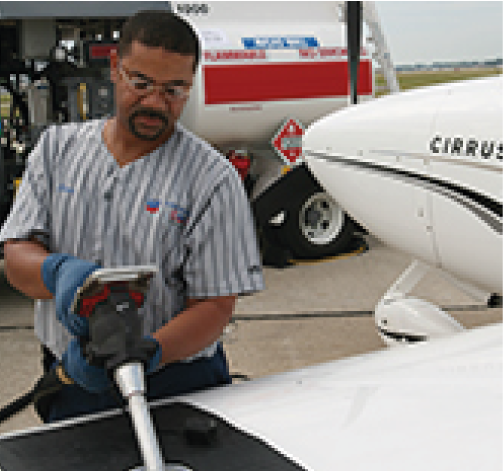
69 267 166 471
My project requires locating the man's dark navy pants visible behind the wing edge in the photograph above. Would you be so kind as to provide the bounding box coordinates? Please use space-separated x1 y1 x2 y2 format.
41 344 231 423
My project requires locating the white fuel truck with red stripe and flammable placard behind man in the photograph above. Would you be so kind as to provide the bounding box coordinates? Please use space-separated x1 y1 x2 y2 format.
0 1 397 263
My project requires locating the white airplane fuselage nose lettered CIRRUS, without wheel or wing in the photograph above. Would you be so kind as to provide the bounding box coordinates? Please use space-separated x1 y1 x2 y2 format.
303 76 503 292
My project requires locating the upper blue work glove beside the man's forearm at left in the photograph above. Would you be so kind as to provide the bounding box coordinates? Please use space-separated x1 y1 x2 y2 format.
42 254 100 337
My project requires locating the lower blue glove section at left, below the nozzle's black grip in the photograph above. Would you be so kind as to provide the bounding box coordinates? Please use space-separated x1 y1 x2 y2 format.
61 339 112 394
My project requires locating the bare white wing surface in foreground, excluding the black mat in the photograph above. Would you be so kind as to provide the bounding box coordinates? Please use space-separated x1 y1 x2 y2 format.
188 325 503 471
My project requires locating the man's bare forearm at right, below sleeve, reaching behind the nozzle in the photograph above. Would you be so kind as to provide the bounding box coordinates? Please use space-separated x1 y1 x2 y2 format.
153 296 236 363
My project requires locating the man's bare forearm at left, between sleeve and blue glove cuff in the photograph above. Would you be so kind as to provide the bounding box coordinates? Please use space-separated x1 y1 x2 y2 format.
4 240 52 299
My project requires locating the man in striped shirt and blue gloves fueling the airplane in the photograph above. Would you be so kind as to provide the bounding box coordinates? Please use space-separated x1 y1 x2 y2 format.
0 11 263 422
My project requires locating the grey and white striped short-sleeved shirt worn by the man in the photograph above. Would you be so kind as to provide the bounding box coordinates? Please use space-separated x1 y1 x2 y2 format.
0 120 263 359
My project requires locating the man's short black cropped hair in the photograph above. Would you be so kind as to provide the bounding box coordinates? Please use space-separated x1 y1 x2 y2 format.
119 10 201 70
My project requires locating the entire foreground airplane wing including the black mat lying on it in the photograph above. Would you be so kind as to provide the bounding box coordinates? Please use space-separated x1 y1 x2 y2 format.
0 325 503 471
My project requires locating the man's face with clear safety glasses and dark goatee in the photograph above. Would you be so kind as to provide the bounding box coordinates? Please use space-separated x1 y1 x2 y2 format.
111 41 194 142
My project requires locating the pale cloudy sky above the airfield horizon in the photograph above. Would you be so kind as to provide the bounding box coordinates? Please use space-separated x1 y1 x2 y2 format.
375 1 503 66
